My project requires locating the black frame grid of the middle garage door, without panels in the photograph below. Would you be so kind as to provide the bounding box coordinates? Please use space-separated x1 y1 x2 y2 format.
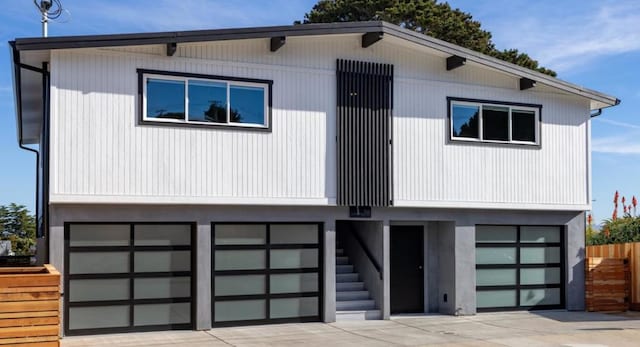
211 221 325 328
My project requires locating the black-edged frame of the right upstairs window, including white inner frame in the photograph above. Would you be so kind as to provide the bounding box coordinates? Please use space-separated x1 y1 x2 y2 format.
447 96 542 148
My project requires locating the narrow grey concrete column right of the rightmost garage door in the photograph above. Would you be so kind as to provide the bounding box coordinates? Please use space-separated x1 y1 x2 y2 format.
565 212 585 311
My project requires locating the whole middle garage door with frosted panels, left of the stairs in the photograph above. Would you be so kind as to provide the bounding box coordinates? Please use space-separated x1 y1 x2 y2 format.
212 223 322 326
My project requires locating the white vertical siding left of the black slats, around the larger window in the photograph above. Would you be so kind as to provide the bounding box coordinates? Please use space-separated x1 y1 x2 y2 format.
51 52 335 204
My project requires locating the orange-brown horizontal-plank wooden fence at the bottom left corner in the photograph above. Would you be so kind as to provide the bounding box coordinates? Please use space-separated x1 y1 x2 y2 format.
0 265 60 347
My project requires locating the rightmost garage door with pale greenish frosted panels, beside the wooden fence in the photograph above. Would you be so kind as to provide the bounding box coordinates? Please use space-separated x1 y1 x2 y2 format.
476 225 564 311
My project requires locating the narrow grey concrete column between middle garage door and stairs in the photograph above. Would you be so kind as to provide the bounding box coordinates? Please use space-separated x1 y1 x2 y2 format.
324 220 336 323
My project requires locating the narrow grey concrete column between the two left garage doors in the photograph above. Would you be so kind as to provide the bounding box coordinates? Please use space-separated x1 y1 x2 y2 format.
191 221 212 330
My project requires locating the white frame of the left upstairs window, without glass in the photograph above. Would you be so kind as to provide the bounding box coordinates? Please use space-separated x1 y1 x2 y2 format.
142 73 271 129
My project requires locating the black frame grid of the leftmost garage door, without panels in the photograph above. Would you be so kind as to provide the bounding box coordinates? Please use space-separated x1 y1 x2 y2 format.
63 221 197 336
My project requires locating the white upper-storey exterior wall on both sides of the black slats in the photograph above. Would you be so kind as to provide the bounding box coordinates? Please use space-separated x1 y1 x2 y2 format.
50 35 589 209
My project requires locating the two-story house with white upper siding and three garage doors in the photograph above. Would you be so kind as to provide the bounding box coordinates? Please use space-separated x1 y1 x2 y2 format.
11 22 619 334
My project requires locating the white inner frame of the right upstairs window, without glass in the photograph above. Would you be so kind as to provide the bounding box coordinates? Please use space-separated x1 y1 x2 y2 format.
449 99 541 146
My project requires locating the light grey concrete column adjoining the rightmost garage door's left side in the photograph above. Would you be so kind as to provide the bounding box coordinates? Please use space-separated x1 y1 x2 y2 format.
454 224 476 315
